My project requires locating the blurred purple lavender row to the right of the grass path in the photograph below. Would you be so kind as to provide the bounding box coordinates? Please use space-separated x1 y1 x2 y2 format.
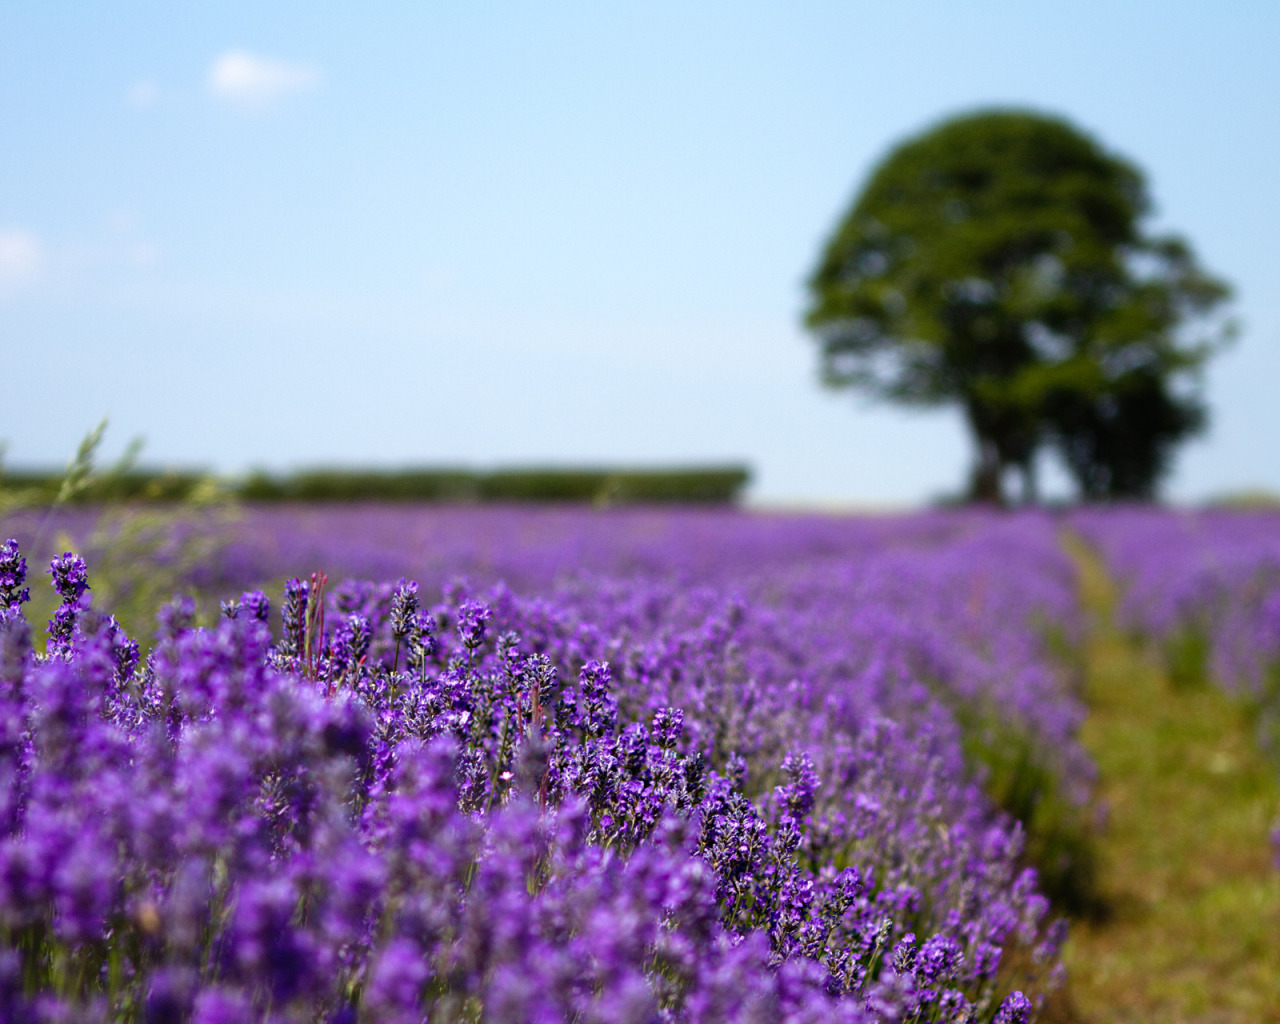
1071 507 1280 758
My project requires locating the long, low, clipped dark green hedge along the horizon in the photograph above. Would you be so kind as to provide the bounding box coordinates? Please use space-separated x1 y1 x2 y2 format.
0 466 750 504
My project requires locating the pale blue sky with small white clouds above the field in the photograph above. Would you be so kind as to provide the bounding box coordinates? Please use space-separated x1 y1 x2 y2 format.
0 0 1280 504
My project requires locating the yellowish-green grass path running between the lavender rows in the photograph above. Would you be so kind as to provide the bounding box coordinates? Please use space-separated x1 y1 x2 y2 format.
1066 539 1280 1024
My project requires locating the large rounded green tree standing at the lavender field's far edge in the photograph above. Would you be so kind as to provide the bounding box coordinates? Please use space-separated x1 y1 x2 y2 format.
806 110 1229 500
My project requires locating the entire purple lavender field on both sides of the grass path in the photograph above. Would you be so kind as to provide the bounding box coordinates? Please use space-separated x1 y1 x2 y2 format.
0 506 1280 1024
